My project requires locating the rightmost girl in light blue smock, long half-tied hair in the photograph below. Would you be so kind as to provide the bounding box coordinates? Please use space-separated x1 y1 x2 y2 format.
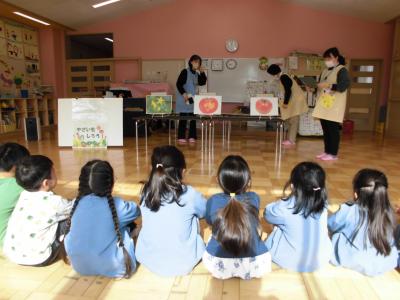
328 169 398 276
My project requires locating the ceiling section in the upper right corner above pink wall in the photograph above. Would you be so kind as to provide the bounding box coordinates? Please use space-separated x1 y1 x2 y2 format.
283 0 400 22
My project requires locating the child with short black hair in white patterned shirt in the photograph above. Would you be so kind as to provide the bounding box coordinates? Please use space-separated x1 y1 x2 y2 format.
3 155 72 266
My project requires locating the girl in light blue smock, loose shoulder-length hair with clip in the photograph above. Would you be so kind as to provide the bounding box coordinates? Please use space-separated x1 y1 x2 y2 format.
264 162 332 272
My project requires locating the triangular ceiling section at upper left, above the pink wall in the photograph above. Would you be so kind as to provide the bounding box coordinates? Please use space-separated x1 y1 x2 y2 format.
5 0 173 29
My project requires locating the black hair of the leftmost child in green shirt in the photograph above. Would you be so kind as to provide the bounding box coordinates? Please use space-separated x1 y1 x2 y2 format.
0 143 29 172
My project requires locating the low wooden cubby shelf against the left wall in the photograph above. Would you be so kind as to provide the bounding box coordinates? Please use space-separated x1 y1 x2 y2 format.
0 95 58 133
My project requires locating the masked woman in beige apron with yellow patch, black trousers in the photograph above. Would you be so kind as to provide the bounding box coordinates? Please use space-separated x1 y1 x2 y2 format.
313 48 350 161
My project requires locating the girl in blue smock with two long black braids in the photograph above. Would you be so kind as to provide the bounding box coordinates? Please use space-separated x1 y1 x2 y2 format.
64 160 140 278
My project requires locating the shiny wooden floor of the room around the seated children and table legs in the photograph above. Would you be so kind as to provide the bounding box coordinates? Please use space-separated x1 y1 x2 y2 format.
0 127 400 300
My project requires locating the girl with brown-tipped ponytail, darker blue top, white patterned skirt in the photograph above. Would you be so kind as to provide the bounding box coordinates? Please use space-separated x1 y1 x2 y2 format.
203 155 271 279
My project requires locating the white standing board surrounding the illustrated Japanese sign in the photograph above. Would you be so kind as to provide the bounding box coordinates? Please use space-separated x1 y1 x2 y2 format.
58 98 124 147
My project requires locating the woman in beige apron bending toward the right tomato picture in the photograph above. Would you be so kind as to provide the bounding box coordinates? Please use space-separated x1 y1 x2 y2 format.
267 64 308 146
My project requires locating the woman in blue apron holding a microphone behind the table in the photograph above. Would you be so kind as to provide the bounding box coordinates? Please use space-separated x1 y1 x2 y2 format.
176 55 207 144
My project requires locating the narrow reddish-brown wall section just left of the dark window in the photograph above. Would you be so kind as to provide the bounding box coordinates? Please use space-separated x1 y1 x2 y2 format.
39 29 66 98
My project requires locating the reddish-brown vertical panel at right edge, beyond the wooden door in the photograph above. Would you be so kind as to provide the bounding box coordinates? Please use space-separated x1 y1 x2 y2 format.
386 17 400 137
